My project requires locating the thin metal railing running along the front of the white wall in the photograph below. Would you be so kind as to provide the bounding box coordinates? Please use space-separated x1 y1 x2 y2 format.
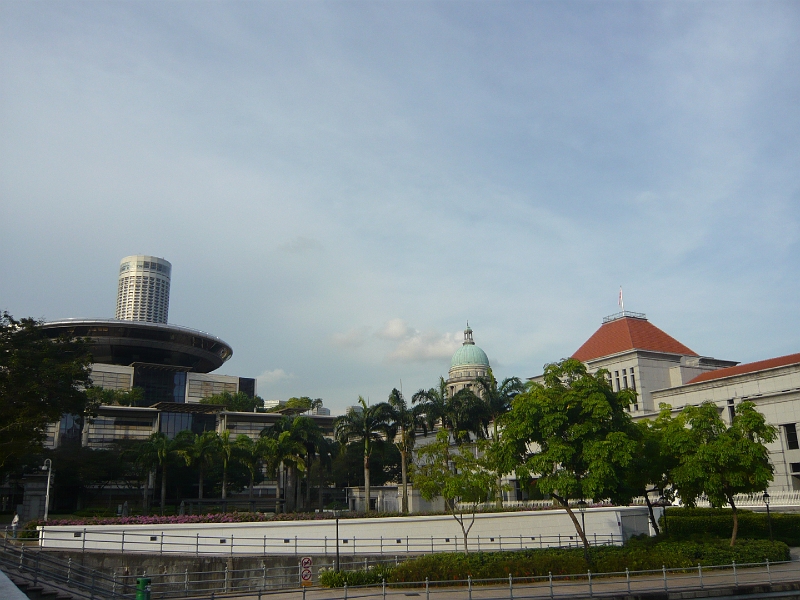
32 529 623 556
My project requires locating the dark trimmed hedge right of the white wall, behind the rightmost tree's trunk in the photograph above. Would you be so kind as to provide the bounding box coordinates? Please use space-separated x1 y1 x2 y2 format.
660 508 800 546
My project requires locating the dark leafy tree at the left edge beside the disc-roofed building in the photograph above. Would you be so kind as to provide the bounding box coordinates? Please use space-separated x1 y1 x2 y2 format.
0 312 94 467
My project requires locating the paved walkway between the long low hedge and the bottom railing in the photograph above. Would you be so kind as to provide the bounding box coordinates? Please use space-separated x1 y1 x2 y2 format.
220 562 800 600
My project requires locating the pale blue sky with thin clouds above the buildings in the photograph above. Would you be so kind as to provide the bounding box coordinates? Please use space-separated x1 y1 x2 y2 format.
0 0 800 414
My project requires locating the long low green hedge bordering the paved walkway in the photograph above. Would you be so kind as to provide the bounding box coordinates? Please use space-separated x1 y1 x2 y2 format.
320 538 789 587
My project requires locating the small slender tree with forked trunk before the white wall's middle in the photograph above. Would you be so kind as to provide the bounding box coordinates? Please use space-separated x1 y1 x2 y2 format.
414 430 494 554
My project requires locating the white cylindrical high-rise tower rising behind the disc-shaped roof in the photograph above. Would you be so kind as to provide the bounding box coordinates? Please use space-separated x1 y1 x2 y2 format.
116 254 172 323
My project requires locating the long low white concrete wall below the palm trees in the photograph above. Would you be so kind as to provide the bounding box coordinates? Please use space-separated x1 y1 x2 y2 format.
39 507 650 556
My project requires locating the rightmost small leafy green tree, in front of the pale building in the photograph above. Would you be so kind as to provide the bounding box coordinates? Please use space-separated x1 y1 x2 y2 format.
664 402 777 546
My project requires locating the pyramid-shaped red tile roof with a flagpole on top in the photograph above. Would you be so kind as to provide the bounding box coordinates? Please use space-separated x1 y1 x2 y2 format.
572 317 697 362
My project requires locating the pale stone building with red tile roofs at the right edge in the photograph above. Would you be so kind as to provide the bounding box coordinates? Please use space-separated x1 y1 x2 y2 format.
531 311 800 494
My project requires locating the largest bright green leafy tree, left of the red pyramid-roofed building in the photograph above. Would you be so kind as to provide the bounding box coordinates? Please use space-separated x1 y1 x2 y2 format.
491 358 636 561
